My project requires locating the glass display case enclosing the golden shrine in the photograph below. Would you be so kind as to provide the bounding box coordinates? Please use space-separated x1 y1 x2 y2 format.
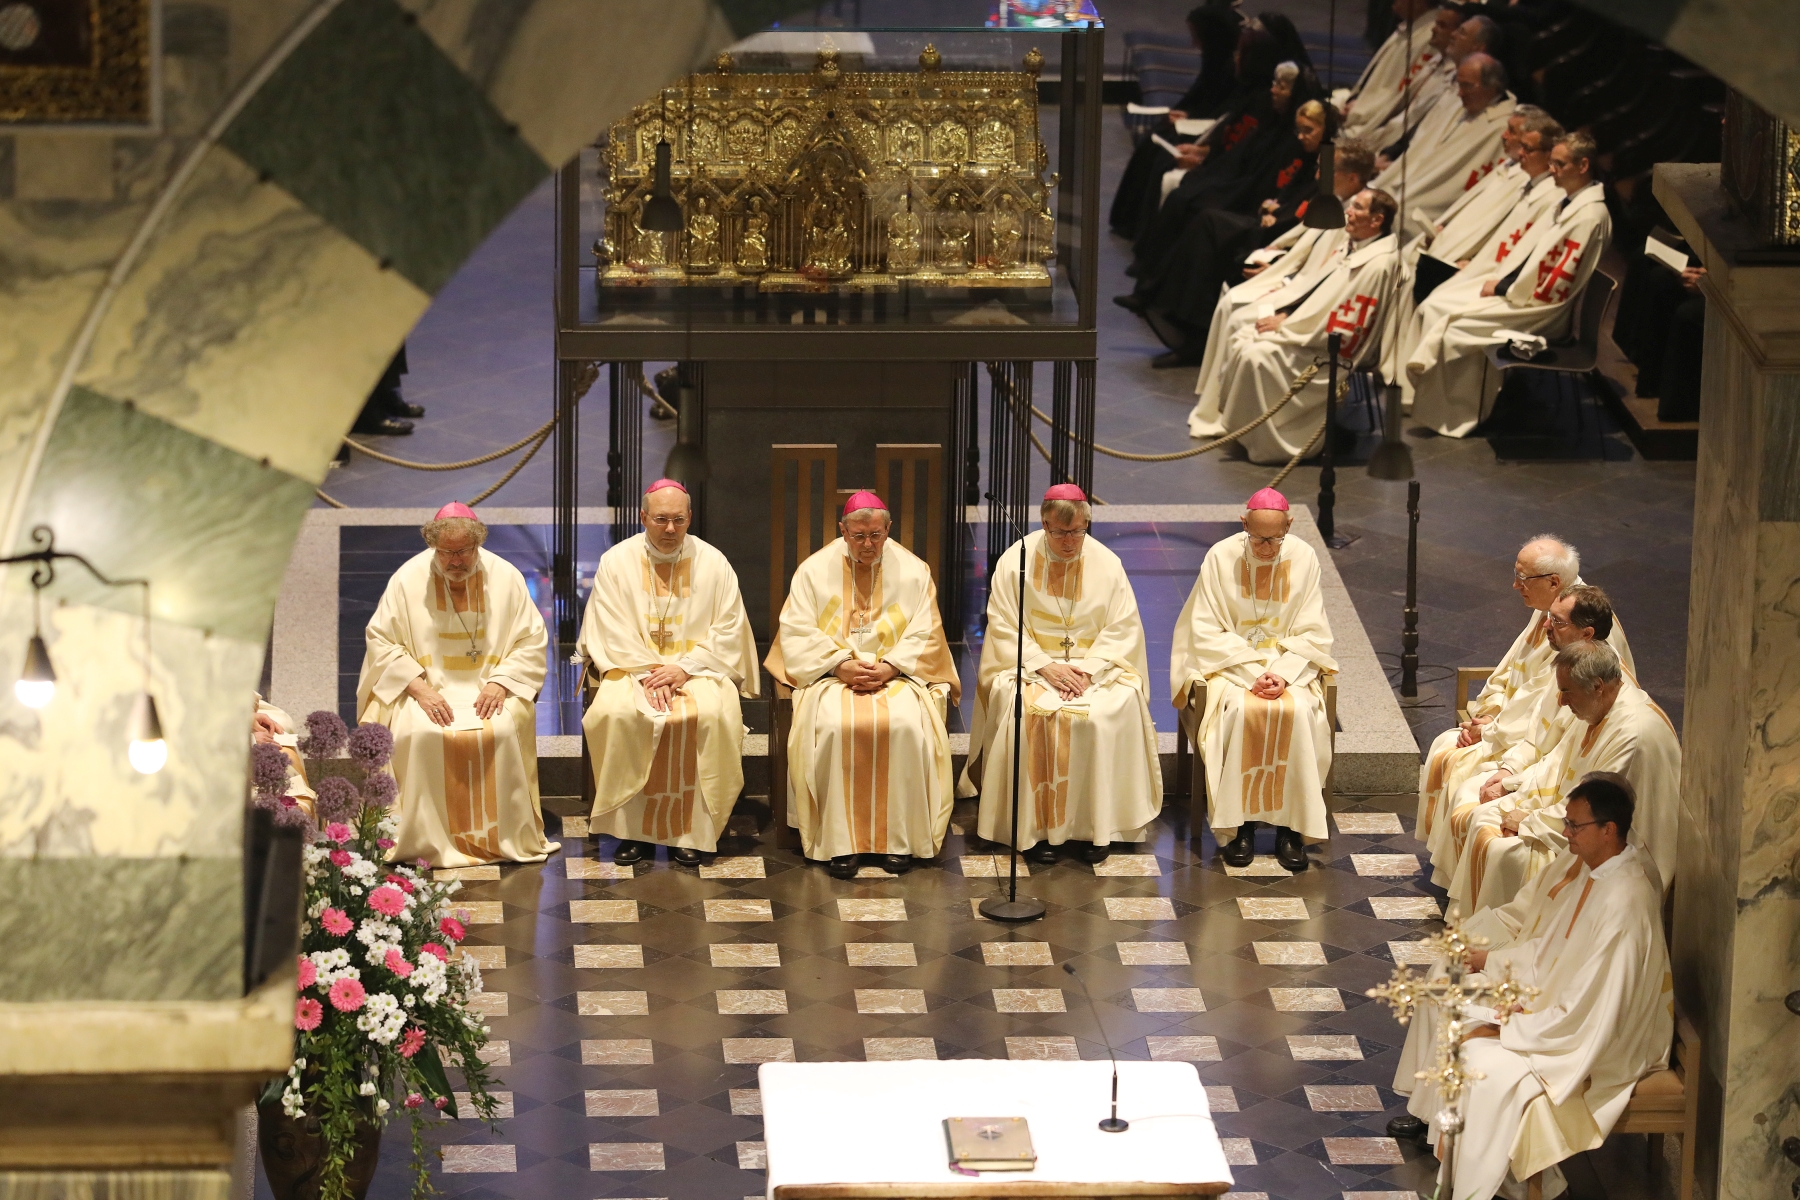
558 0 1103 362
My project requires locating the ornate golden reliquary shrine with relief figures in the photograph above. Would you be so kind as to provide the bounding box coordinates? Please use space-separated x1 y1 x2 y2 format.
594 45 1057 291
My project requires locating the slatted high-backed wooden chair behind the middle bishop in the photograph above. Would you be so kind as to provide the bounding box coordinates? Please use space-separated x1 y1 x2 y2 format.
769 443 943 849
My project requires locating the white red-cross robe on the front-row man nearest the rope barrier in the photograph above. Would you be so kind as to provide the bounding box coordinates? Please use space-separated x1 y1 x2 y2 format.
1219 234 1400 462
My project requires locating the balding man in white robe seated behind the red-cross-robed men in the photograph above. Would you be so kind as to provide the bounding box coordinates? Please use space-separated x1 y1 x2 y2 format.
1372 52 1514 237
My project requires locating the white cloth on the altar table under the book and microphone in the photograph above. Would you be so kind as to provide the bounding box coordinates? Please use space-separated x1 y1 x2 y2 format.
758 1058 1231 1200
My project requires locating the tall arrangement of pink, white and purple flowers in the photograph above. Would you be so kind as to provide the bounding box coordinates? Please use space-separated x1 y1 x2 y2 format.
250 712 495 1200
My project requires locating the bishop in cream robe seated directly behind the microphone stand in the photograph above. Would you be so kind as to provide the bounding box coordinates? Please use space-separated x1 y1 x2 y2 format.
961 484 1163 864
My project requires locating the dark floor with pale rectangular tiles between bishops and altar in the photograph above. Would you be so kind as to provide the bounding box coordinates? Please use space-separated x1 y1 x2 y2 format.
284 797 1490 1200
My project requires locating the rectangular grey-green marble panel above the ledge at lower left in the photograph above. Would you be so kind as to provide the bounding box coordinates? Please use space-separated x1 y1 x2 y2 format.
0 856 243 1002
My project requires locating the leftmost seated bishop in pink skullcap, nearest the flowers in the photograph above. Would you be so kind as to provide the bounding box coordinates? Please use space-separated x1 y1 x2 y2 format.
356 504 558 867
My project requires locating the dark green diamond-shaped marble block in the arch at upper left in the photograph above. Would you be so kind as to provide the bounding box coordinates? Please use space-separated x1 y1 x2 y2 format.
223 0 547 291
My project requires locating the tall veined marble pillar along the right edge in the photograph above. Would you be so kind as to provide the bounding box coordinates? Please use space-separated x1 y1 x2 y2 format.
1656 164 1800 1200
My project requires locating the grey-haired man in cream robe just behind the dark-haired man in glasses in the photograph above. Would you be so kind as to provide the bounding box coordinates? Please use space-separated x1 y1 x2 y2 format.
1447 640 1681 912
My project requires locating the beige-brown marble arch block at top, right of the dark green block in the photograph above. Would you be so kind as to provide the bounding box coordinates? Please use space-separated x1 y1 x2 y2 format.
400 0 738 164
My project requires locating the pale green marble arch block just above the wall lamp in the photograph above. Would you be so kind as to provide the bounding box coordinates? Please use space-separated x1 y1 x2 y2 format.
14 387 313 644
